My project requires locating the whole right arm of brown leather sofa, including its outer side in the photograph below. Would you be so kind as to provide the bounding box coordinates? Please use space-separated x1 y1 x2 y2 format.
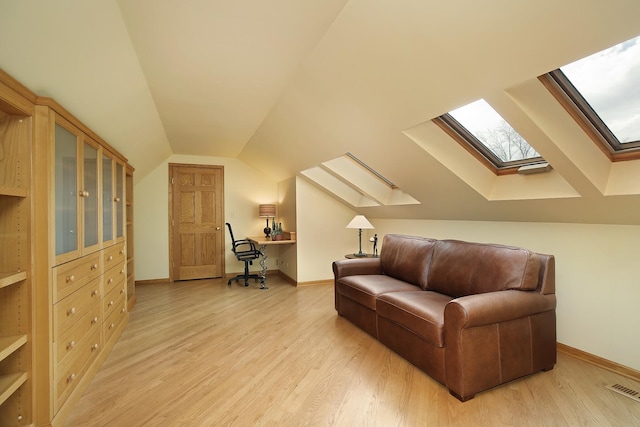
444 290 556 401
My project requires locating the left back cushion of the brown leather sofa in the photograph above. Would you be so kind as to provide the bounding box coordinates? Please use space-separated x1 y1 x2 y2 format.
380 234 436 289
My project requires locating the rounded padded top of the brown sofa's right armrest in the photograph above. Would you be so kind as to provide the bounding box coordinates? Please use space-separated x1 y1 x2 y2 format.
444 290 556 329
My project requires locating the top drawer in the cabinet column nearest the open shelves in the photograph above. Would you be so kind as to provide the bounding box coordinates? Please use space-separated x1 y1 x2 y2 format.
53 252 103 303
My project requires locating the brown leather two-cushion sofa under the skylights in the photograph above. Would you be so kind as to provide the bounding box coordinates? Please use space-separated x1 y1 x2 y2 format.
333 234 556 402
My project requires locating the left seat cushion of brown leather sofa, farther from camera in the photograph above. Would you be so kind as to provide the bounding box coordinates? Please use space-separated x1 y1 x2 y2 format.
336 274 422 310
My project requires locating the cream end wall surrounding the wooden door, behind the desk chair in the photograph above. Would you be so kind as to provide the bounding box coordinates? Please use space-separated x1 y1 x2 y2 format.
133 155 277 280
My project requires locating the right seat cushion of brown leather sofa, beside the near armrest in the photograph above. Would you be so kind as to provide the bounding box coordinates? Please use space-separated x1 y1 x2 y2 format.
376 291 453 347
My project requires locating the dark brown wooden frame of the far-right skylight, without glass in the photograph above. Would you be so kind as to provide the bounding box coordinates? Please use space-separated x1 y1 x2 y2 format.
538 68 640 162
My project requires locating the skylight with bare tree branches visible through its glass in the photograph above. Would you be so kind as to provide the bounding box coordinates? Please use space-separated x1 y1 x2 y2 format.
434 99 544 173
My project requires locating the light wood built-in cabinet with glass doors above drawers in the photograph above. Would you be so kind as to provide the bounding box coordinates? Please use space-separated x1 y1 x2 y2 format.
34 98 132 425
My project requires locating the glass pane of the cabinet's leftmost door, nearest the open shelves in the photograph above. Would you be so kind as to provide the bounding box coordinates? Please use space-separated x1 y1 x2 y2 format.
54 124 79 256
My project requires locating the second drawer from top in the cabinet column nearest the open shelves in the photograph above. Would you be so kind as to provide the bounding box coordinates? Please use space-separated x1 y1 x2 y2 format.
53 277 102 341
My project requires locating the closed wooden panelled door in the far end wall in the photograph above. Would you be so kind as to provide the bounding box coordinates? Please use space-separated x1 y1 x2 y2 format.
169 164 224 280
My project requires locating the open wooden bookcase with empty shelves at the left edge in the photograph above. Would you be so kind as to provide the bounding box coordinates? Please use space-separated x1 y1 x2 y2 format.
0 70 35 426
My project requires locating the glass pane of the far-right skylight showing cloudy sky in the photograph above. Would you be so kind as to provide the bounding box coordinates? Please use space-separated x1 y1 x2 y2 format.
560 36 640 144
